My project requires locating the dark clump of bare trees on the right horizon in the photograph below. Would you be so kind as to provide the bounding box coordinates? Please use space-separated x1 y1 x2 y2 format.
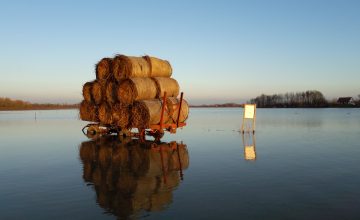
250 90 329 108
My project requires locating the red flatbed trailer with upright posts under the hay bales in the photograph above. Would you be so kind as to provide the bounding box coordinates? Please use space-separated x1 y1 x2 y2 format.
82 92 186 141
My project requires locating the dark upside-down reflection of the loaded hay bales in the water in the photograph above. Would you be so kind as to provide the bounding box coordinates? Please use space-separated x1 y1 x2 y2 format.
79 138 189 219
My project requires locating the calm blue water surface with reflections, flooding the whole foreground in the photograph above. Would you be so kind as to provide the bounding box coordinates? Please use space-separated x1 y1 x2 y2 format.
0 109 360 219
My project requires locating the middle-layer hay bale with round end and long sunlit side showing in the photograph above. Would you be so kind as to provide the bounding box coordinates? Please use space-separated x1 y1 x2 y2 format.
118 78 157 105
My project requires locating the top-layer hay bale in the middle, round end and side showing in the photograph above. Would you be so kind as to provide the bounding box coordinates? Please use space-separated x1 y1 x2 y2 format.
112 55 150 82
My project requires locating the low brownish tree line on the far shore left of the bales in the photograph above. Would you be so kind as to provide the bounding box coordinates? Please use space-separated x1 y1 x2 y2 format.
0 97 79 110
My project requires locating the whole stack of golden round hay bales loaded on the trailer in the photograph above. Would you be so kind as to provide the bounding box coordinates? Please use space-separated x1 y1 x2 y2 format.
79 55 189 129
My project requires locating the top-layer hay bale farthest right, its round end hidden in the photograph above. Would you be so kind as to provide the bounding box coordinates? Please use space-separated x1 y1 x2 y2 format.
144 56 172 77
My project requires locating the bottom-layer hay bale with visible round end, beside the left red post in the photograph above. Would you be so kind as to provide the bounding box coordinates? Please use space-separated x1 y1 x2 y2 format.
132 99 169 128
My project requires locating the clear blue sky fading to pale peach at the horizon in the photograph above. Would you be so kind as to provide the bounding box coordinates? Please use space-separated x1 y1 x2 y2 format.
0 0 360 104
